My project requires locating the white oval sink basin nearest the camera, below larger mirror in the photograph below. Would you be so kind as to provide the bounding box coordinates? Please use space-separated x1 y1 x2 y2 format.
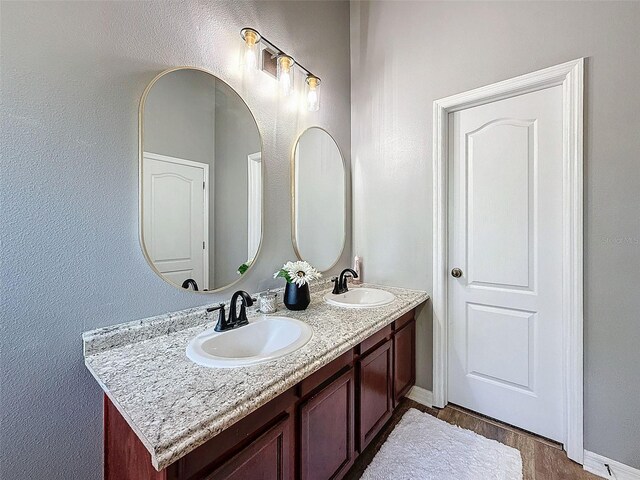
187 315 313 368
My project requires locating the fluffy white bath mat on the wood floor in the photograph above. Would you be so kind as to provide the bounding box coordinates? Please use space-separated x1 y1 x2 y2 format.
362 408 522 480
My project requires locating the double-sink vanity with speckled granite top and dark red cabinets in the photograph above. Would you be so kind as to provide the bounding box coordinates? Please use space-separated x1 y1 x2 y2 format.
83 284 428 480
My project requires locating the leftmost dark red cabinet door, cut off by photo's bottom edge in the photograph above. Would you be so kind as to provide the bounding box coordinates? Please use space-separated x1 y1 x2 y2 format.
203 415 294 480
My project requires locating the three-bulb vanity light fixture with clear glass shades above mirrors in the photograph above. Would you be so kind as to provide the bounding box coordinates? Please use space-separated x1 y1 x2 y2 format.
240 27 320 112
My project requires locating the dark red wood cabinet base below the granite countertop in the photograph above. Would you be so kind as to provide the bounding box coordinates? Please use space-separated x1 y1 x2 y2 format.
104 311 415 480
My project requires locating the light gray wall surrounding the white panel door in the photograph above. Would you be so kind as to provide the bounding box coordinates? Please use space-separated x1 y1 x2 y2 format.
351 1 640 468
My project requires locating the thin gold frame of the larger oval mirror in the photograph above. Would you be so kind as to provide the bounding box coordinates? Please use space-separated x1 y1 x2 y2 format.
138 66 265 294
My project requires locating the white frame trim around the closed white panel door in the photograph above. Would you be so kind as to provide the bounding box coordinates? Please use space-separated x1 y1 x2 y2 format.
432 58 584 464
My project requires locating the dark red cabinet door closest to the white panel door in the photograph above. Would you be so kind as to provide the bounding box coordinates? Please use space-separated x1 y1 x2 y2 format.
393 320 416 406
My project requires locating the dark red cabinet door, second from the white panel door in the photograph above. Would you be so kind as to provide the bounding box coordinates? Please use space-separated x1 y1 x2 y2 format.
358 340 393 452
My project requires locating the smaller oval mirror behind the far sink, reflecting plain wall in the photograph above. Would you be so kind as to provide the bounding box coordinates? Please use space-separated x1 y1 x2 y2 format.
292 127 346 271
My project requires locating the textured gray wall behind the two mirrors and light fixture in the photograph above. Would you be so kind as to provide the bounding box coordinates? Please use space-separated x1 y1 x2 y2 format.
0 1 351 480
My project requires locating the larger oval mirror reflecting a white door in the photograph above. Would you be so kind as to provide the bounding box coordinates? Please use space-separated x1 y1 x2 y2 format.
140 68 263 291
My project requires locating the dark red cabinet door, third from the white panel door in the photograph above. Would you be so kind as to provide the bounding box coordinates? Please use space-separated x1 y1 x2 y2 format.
300 368 355 480
